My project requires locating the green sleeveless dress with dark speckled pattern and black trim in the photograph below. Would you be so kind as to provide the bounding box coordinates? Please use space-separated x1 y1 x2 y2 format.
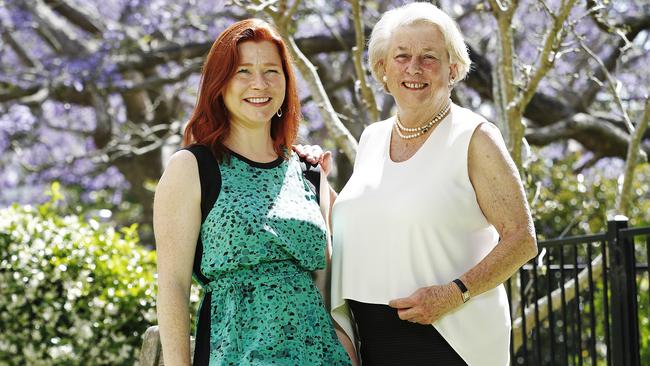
188 146 350 366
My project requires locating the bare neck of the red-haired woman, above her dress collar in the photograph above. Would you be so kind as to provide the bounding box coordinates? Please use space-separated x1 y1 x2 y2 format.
224 122 278 162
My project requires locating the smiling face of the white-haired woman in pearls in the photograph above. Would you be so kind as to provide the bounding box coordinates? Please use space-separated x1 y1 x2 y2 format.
383 23 456 109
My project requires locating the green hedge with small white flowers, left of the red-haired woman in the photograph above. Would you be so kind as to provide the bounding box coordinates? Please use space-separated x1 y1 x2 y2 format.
0 184 156 365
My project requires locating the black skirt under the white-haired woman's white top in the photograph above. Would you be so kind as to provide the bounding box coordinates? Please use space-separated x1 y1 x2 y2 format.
348 300 467 366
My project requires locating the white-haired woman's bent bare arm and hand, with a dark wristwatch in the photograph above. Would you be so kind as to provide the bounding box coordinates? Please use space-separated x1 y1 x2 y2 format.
388 123 537 324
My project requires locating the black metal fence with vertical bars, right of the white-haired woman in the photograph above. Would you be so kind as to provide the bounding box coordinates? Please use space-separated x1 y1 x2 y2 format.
505 216 650 366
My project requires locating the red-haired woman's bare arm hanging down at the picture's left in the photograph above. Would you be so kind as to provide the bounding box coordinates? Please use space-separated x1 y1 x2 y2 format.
154 150 201 365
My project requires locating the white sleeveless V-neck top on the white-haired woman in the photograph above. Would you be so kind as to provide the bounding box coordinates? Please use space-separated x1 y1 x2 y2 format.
332 104 510 366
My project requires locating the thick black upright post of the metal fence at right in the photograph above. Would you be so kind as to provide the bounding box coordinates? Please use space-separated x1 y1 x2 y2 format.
607 215 641 366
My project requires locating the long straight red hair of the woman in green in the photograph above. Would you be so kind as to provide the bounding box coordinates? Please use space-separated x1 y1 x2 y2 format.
183 19 300 161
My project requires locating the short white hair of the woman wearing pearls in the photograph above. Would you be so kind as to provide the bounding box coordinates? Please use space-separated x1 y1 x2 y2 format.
368 2 472 84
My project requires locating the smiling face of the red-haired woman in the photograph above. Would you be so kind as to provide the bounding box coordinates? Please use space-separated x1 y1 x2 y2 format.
223 41 286 128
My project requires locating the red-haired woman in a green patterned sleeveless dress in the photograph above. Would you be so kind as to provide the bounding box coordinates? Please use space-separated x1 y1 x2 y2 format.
154 19 351 365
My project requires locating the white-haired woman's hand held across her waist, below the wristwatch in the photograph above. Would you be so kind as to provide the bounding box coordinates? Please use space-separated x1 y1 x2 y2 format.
388 283 463 325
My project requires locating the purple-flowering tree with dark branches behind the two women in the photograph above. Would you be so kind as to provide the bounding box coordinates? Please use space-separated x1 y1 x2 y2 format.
0 0 650 237
